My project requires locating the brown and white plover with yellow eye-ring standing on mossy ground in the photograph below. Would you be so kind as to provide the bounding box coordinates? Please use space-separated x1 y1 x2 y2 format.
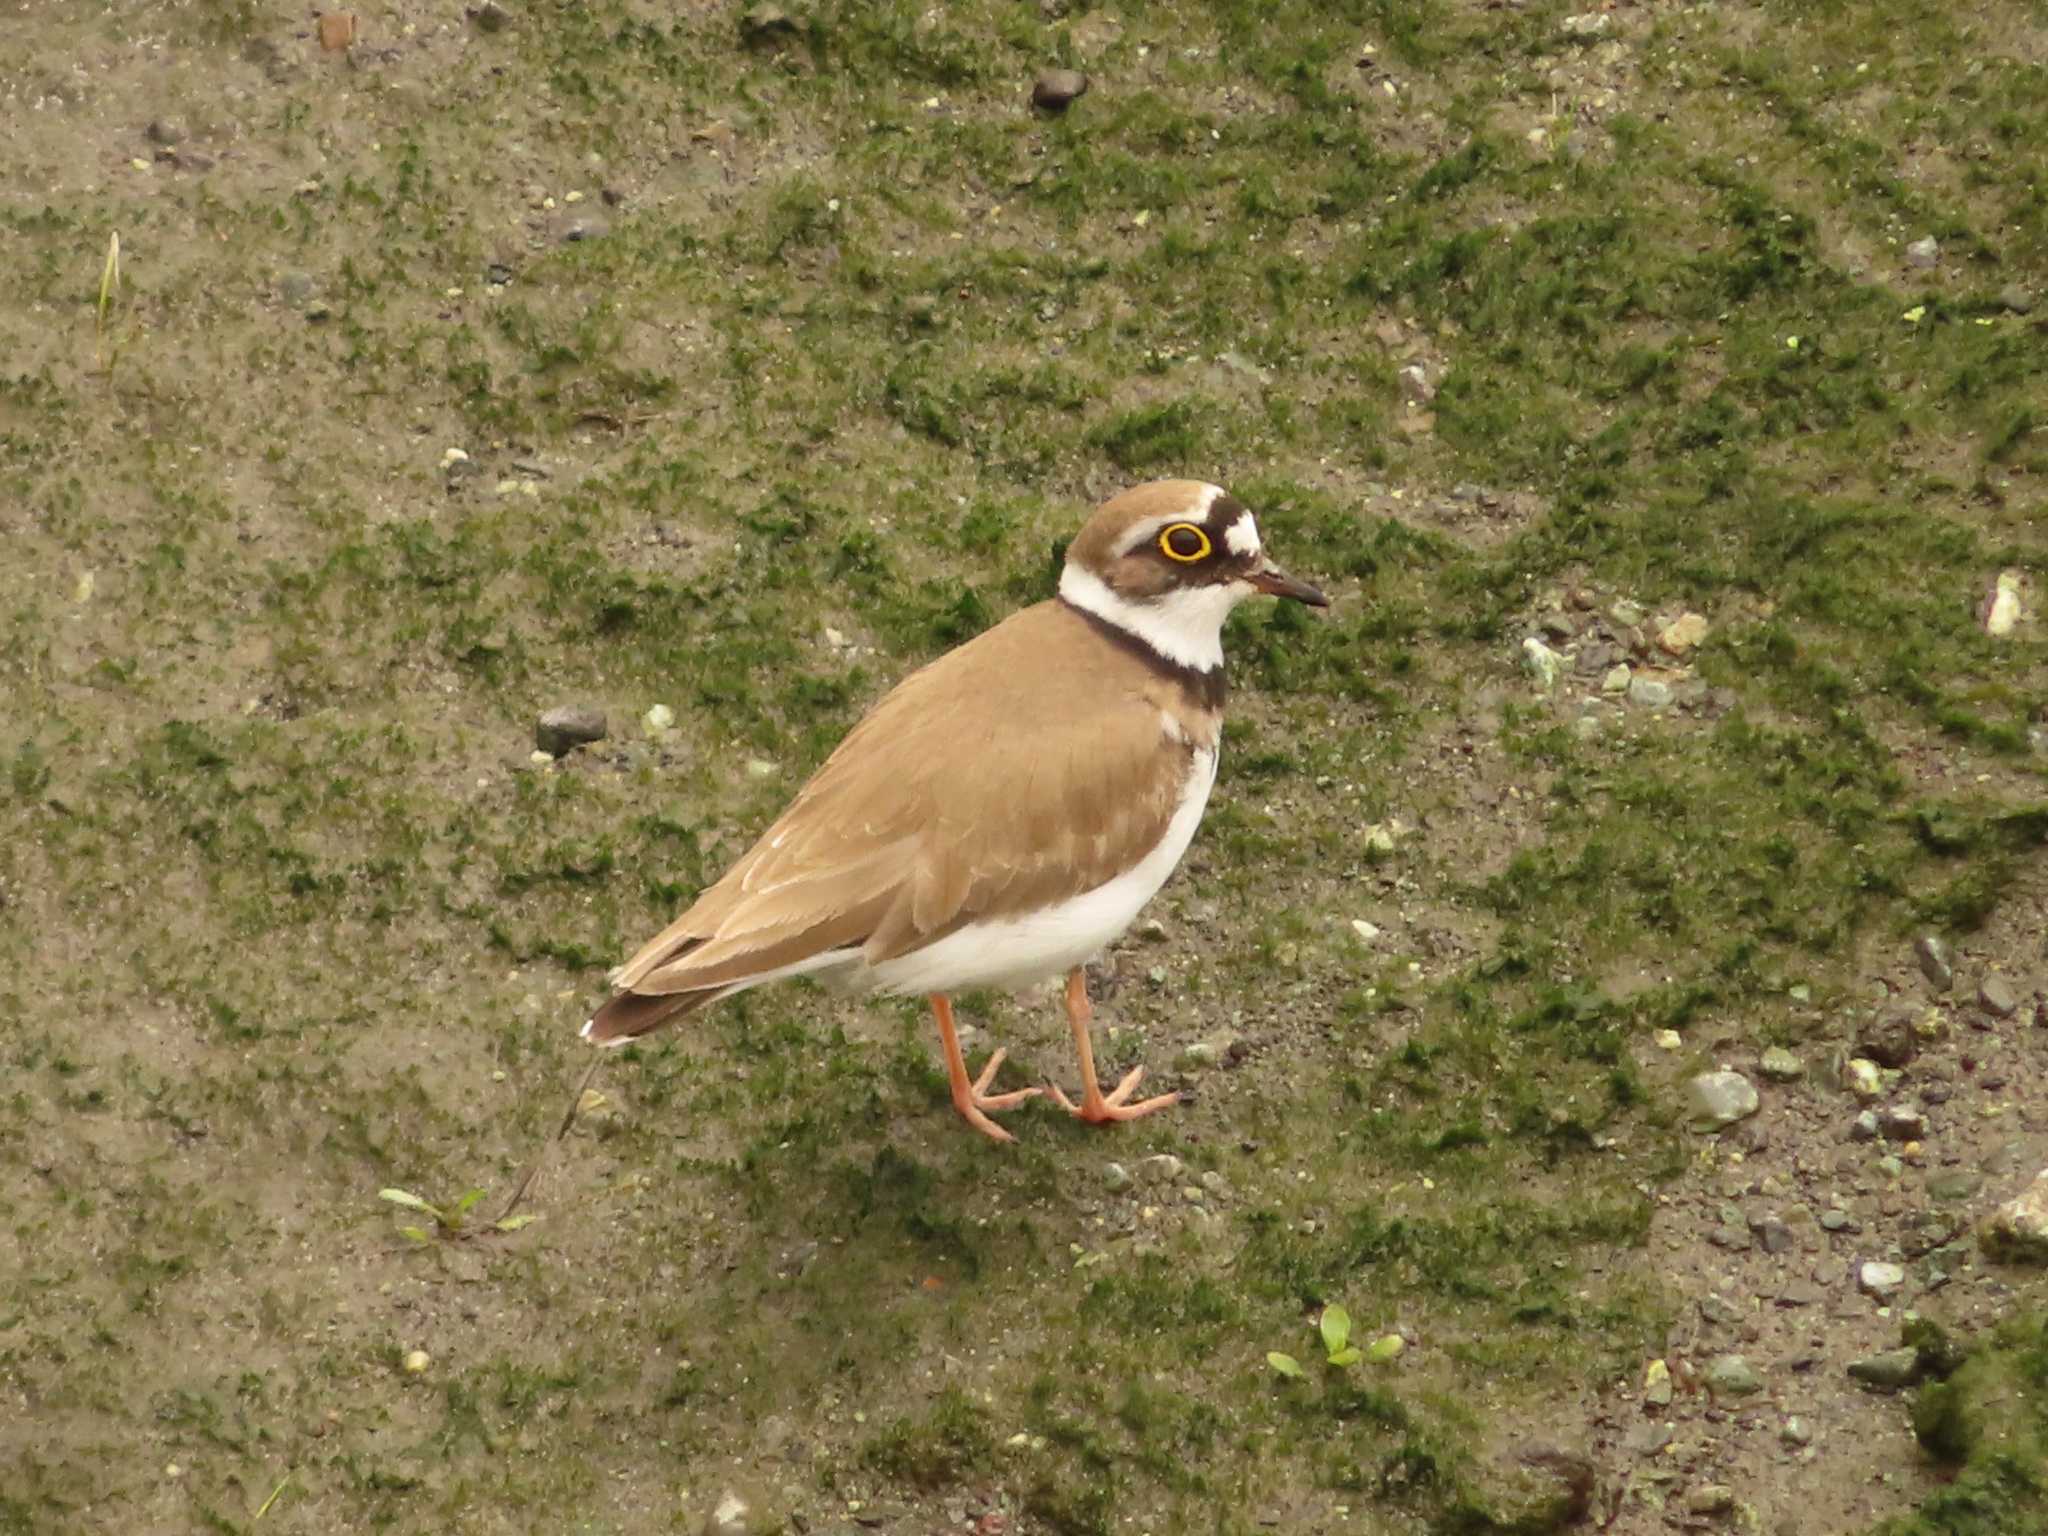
582 479 1329 1141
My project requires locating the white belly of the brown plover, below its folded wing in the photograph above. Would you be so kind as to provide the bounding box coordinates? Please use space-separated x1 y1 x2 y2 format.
851 752 1217 993
